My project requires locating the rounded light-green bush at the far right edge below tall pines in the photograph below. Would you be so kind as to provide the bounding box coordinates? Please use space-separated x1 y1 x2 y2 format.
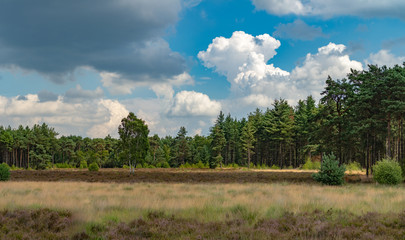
373 159 402 185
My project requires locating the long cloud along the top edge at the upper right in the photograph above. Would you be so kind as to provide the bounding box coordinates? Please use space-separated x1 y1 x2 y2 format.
252 0 405 19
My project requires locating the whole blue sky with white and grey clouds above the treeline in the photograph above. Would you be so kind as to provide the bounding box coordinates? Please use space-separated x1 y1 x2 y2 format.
0 0 405 138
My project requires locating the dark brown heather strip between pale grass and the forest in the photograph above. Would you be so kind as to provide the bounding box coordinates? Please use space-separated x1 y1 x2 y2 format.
11 169 370 183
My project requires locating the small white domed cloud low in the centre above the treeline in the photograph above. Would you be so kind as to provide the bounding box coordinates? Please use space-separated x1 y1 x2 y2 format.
169 91 221 117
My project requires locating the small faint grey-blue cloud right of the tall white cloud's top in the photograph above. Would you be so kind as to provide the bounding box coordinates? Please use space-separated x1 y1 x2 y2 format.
273 19 327 41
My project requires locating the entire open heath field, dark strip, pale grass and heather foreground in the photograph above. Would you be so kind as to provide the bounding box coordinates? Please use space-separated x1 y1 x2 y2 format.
0 169 405 240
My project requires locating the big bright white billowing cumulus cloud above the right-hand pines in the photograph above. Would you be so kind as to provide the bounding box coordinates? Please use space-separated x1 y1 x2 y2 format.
198 32 362 109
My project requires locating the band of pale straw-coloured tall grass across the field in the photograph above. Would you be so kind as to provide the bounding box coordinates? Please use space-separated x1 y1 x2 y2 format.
0 182 405 227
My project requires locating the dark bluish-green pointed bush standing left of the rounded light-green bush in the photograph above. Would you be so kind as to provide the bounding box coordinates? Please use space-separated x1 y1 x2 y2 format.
312 154 346 185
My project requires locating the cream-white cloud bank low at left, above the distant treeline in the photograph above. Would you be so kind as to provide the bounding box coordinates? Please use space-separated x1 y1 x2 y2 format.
0 94 128 137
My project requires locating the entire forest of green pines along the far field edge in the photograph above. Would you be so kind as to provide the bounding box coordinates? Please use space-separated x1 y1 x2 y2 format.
0 63 405 174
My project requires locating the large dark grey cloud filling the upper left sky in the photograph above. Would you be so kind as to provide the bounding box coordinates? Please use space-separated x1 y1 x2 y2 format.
0 0 185 82
